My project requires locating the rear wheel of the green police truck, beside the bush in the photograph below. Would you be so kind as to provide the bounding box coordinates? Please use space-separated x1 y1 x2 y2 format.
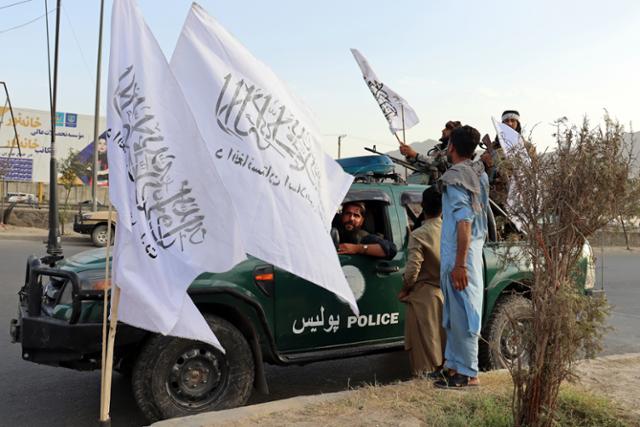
478 294 533 369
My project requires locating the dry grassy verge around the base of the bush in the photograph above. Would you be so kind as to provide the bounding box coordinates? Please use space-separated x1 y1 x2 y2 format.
253 372 640 427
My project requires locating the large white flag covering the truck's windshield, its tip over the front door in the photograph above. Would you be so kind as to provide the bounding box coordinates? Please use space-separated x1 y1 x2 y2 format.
171 4 357 312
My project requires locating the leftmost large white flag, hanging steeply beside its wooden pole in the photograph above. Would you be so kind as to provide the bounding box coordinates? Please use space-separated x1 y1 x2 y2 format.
107 0 245 347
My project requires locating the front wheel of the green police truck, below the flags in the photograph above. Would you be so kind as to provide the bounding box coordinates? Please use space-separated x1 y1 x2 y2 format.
132 314 255 422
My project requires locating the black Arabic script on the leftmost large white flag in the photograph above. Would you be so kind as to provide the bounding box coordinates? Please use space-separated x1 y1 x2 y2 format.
109 65 206 258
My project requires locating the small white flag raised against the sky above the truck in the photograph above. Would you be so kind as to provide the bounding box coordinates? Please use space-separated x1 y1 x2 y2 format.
351 49 420 133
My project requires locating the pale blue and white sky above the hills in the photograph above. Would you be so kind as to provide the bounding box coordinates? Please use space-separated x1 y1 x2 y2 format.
0 0 640 156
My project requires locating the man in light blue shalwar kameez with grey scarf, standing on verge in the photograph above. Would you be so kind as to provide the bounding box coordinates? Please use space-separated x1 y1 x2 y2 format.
436 126 489 388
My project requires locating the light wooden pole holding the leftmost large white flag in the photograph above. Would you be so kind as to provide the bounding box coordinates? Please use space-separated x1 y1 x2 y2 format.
100 202 115 426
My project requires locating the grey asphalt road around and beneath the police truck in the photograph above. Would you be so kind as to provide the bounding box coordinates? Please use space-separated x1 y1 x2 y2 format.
0 236 640 427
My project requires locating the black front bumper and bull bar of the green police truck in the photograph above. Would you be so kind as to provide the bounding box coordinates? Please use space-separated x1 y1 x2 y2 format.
10 257 148 369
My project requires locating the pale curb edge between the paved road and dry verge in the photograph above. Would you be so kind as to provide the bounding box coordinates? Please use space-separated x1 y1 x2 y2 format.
152 353 640 427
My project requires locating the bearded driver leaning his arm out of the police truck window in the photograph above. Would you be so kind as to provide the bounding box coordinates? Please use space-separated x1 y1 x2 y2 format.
338 202 398 259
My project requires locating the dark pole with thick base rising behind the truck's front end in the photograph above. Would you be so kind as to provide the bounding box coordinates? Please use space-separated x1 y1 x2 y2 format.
43 0 62 266
